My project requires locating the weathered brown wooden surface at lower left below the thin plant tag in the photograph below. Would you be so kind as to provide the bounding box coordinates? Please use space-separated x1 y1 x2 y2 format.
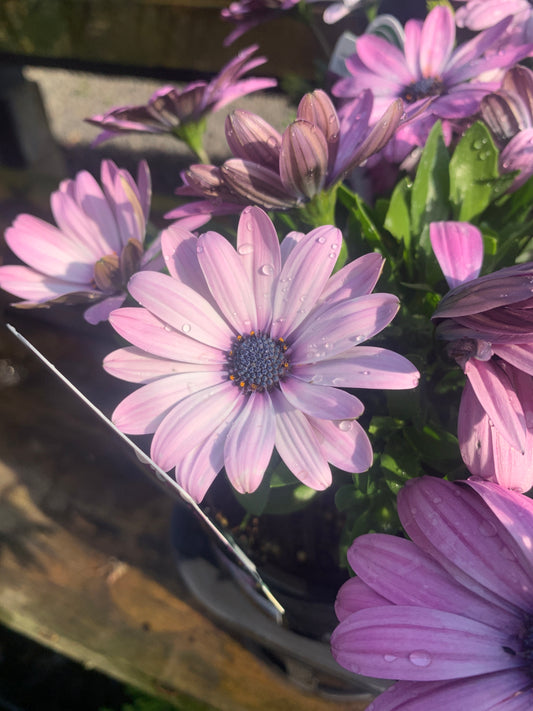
0 318 366 711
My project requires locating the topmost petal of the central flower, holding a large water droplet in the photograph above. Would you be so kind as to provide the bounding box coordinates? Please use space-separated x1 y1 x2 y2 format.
237 207 281 332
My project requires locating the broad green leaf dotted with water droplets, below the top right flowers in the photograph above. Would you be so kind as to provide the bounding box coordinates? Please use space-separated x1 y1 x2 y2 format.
450 121 499 222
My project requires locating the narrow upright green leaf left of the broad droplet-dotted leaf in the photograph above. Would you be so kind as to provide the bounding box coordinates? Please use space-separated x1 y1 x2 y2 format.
411 122 450 235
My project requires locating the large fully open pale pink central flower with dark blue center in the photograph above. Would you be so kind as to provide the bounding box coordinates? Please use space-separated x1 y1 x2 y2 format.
104 207 418 501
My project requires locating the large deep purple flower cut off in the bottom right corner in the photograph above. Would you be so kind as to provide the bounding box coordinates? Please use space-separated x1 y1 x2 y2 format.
331 477 533 711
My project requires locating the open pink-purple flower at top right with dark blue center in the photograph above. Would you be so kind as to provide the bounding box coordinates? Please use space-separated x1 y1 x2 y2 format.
333 5 533 144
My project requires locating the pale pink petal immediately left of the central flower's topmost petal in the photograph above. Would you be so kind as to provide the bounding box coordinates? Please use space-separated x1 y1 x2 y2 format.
196 232 257 334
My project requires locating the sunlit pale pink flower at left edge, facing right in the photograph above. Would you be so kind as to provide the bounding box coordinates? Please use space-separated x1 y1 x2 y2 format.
0 160 163 324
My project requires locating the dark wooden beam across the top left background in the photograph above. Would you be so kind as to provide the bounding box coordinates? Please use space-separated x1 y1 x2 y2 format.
0 0 337 78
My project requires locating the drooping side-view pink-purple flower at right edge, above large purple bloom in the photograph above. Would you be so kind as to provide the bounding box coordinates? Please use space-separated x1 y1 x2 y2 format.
430 222 533 491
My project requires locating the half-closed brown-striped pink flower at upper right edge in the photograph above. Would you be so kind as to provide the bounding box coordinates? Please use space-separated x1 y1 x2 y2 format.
481 65 533 190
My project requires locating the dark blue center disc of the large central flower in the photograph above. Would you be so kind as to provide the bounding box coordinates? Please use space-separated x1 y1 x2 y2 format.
228 331 289 392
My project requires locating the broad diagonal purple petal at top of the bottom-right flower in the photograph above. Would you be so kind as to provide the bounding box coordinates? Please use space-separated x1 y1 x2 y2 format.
398 477 533 614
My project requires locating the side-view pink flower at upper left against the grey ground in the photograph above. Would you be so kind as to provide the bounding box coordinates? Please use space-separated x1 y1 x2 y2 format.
86 45 277 145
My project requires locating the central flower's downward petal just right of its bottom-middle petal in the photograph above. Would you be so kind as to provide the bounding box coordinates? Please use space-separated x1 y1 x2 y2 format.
271 390 331 491
